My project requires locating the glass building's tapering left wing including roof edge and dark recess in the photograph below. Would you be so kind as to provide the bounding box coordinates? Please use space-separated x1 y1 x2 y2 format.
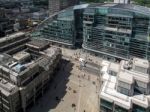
32 4 88 47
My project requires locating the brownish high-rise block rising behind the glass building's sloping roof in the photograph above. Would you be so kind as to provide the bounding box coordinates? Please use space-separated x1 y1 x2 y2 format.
49 0 79 15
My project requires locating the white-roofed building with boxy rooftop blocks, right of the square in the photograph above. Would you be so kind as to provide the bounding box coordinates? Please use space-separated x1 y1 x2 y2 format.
100 58 150 112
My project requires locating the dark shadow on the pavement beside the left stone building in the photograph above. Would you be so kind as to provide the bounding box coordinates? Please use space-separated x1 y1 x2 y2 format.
28 59 73 112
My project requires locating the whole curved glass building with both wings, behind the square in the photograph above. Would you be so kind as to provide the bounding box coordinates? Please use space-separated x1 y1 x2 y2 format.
32 4 150 59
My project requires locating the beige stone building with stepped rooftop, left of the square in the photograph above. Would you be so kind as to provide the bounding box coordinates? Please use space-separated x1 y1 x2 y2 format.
0 32 61 112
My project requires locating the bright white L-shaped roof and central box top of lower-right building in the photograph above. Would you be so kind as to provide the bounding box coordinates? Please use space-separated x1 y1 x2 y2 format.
100 61 150 109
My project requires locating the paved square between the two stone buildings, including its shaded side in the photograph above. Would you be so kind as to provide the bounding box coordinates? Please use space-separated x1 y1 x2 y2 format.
29 60 99 112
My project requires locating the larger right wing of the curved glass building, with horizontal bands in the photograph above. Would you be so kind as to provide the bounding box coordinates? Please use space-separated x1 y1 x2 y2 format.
83 4 150 59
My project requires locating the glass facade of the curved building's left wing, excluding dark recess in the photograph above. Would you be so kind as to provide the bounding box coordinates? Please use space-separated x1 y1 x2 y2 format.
41 9 75 45
